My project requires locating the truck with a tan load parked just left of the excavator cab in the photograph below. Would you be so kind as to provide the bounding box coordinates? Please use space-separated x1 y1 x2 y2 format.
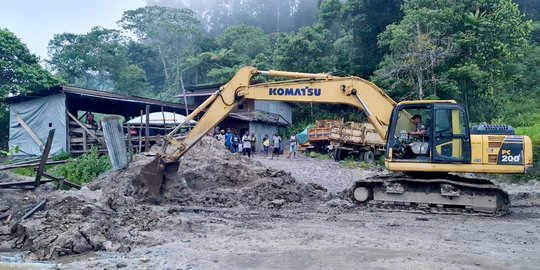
329 122 385 163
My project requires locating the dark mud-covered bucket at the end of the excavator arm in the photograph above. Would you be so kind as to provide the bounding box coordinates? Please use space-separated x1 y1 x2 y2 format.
136 156 180 197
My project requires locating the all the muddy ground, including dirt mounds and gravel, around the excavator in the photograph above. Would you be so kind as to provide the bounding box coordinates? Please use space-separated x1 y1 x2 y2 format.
0 140 540 269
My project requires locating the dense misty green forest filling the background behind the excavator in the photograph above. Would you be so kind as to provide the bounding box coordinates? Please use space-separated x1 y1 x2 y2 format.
0 0 540 148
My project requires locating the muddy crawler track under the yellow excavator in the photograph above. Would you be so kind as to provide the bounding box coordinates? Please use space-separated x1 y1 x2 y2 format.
348 174 510 216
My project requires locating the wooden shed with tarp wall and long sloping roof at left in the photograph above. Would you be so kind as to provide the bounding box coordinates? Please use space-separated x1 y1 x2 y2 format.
6 86 190 155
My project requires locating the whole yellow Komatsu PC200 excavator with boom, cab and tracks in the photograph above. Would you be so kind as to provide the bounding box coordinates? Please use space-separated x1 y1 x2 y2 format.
137 67 533 215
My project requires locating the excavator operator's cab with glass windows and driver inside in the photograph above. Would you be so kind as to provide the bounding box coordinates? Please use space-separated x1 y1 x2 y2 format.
386 101 471 164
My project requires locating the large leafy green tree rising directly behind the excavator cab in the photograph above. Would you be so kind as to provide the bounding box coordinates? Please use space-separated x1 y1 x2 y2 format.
373 0 532 121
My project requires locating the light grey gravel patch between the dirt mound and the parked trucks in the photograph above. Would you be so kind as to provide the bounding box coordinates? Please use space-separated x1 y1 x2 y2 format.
253 154 377 193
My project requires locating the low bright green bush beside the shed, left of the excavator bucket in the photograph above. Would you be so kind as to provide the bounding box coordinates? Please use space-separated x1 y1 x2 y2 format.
52 148 111 184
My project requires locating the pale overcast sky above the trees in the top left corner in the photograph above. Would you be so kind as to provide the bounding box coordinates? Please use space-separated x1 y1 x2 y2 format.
0 0 145 59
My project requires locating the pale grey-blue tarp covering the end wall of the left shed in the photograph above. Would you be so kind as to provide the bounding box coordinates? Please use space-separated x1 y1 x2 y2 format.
9 94 67 156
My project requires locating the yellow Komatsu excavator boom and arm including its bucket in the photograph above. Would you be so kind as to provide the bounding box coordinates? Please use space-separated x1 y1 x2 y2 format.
138 67 396 196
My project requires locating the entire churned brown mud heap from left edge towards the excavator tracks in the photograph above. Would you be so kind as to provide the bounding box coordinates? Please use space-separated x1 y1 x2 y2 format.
0 138 331 259
